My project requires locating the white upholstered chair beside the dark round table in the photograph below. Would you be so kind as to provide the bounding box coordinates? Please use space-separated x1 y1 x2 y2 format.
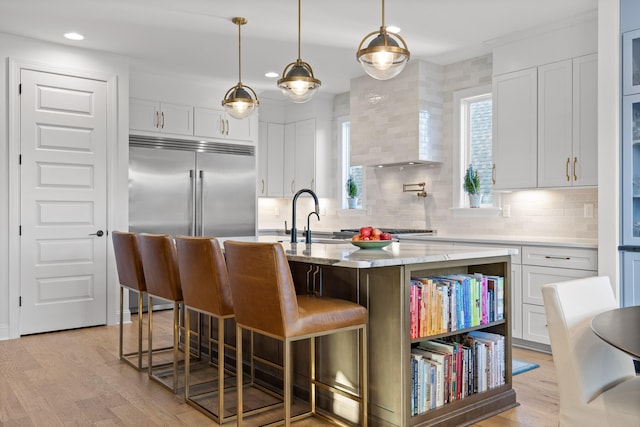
542 277 640 427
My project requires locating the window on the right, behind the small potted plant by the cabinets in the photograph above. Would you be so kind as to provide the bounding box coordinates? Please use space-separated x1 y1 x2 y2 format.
453 86 493 207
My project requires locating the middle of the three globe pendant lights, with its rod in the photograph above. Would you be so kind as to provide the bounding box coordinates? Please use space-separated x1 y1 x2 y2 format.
278 0 321 103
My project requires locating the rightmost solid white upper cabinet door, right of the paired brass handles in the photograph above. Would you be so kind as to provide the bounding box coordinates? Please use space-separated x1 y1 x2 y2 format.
571 54 598 186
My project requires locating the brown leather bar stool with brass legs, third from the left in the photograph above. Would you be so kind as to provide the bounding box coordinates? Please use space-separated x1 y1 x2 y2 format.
176 236 235 424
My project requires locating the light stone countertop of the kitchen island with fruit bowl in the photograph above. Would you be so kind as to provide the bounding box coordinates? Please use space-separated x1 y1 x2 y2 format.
218 236 517 268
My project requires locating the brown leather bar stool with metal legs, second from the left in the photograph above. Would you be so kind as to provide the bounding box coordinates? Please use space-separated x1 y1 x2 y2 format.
138 233 182 393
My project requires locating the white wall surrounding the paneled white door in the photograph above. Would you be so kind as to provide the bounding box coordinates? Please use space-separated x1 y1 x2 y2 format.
0 34 129 339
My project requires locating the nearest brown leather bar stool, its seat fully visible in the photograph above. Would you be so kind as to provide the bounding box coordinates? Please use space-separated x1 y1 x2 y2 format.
224 241 368 427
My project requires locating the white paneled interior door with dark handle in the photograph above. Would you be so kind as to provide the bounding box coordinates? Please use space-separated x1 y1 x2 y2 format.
20 69 108 335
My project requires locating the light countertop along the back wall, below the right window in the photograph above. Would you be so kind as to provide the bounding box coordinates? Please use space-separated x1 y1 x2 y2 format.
400 234 598 249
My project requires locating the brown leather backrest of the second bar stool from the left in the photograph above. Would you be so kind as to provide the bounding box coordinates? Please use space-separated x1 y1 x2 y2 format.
138 233 182 301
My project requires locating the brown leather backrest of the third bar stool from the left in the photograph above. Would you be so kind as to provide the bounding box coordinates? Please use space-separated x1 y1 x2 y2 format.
176 236 233 316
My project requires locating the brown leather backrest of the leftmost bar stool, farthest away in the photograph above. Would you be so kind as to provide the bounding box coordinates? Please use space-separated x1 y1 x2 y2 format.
111 231 147 292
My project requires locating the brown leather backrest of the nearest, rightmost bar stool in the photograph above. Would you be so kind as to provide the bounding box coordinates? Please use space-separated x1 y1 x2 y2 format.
224 240 299 339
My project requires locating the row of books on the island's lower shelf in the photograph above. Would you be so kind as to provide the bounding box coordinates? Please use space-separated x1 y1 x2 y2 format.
411 331 505 416
